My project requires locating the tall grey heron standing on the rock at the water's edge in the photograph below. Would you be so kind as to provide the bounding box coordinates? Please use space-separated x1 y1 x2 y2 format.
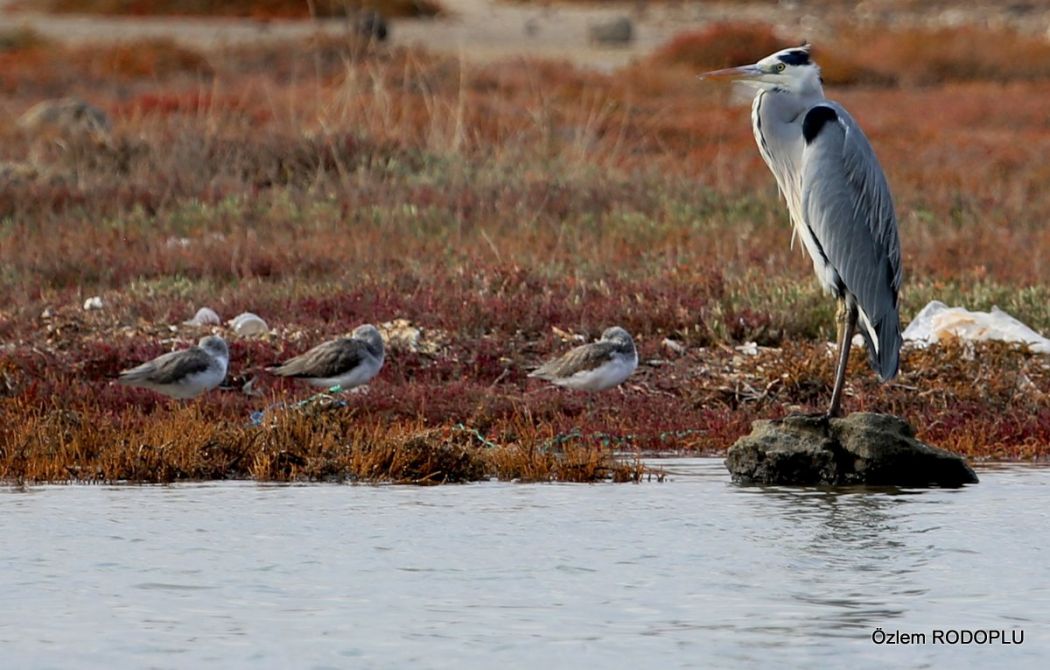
700 44 901 417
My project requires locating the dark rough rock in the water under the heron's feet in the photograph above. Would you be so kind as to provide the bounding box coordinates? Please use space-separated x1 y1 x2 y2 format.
726 412 978 486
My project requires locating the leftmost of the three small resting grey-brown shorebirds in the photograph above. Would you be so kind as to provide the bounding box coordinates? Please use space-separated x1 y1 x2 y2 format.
118 335 230 399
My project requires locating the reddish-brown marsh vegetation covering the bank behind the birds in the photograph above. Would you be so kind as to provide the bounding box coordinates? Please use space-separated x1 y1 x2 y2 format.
0 19 1050 483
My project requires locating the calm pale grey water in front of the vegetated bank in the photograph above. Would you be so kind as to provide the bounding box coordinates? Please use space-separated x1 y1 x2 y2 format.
0 460 1050 669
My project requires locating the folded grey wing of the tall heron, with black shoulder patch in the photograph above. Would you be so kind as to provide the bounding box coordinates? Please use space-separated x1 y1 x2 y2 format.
801 103 902 379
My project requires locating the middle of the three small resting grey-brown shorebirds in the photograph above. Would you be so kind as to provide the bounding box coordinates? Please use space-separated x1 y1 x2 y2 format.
269 323 385 393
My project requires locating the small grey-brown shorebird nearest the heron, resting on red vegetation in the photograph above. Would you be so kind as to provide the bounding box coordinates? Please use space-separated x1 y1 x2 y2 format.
529 327 638 391
